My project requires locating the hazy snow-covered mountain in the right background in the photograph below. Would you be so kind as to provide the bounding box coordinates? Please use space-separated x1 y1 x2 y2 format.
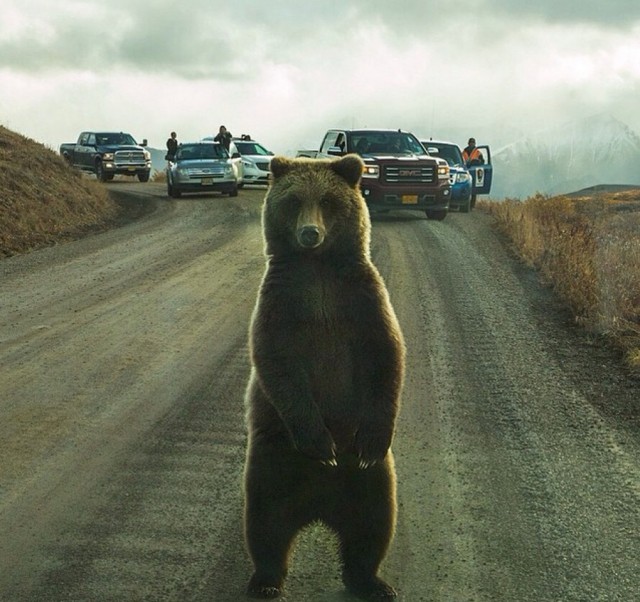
491 114 640 199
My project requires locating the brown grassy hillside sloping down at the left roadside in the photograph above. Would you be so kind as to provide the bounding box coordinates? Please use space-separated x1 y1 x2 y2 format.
0 126 119 257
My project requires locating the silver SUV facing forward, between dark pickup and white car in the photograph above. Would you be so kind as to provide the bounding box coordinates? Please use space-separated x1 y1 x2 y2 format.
167 141 238 198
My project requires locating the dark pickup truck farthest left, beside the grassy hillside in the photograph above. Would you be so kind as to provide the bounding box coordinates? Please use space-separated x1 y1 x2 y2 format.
60 132 151 182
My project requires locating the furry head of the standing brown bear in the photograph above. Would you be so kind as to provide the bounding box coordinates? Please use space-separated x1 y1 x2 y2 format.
262 155 371 256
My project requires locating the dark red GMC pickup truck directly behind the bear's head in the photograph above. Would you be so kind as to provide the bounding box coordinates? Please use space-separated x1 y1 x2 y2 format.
297 129 451 220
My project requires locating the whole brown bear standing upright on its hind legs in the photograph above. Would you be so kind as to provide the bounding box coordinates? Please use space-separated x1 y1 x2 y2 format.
245 155 405 600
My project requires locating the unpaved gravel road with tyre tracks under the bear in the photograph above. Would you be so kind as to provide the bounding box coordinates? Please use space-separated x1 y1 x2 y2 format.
0 183 640 602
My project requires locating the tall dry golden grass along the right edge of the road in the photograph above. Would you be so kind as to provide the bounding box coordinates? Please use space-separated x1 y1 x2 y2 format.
481 191 640 373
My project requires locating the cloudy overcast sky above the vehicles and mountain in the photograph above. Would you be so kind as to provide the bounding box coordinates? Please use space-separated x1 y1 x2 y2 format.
0 0 640 153
